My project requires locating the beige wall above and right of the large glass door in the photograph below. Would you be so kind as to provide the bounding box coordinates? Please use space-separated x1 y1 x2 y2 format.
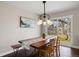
51 8 79 47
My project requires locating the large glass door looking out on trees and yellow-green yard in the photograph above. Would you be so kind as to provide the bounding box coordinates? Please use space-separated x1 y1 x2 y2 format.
47 16 72 41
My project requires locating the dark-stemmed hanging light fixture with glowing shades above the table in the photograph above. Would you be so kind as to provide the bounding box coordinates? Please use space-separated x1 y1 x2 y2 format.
37 1 52 25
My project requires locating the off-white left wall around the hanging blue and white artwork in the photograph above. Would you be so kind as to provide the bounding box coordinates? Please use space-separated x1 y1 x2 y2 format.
0 4 40 54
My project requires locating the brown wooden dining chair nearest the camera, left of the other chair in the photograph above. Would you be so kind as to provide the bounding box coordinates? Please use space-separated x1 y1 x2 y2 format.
39 39 55 57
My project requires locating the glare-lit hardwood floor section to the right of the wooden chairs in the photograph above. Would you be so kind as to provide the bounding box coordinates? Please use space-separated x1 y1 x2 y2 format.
60 47 79 57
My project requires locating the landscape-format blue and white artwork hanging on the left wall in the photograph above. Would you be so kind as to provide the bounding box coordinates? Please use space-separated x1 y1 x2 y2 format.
20 16 34 28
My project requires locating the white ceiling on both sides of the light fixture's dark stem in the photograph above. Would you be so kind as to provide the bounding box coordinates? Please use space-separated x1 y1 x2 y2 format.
0 1 79 15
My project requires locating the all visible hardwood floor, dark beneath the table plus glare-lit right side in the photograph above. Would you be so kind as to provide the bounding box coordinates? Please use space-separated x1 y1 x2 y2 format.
3 46 79 57
